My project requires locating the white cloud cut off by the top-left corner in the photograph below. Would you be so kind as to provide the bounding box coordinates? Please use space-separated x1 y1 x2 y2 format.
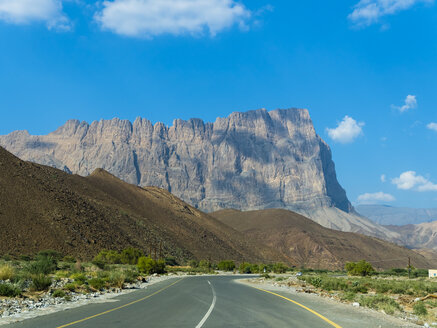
0 0 71 30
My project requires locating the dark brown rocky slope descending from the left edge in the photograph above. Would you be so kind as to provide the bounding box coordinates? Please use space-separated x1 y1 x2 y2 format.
0 147 282 263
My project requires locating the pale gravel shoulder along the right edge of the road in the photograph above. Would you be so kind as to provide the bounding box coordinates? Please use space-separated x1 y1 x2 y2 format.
236 278 424 328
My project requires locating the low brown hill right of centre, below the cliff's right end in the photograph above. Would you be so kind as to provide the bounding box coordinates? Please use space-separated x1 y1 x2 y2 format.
212 209 437 269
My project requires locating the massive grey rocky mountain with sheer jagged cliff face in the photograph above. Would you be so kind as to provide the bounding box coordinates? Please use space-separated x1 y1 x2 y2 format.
0 109 397 240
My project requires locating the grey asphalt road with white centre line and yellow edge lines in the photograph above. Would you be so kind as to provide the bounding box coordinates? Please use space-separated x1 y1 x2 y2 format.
2 276 392 328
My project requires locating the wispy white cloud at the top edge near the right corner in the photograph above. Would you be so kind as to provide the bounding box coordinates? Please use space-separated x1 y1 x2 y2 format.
348 0 434 26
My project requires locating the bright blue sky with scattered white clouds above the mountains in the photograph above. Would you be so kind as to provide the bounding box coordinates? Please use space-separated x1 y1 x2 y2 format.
0 0 437 207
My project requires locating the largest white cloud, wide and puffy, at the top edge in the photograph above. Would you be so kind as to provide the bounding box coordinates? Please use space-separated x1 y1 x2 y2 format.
95 0 251 37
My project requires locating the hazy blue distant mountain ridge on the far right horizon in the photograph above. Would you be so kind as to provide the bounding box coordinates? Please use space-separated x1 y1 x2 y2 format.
355 205 437 226
